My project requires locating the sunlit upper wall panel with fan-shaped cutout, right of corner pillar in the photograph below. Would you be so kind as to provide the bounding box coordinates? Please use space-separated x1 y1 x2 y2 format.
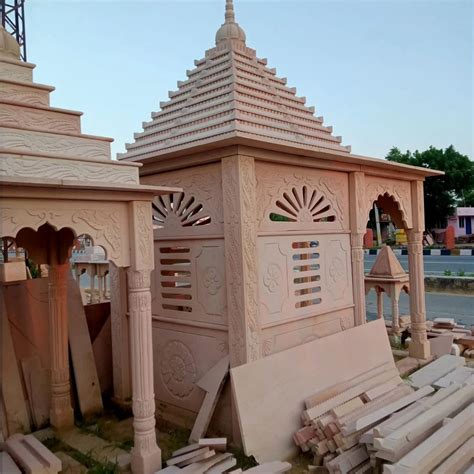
256 162 349 232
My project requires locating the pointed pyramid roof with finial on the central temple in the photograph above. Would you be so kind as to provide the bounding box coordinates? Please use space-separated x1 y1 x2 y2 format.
119 0 350 161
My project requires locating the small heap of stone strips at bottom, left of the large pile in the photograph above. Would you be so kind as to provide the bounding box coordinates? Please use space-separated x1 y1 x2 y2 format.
156 438 291 474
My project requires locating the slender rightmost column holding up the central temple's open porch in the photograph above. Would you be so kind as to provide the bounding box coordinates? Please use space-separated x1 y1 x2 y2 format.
408 181 430 359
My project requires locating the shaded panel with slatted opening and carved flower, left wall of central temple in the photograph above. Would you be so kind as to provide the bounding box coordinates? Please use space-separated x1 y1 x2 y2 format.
152 239 227 326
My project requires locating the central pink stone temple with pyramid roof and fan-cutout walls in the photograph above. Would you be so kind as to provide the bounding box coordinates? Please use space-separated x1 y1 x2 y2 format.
114 0 438 432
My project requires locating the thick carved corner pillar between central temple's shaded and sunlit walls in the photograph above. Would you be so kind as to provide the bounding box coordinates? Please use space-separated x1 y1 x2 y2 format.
222 156 261 367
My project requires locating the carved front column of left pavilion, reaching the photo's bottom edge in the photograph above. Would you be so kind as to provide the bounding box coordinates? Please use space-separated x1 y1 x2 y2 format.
127 202 161 474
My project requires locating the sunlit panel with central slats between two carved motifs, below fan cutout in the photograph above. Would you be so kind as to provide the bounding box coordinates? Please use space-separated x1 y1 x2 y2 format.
258 234 353 327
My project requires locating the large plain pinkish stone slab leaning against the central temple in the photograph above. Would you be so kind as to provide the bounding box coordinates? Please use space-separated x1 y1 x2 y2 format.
231 319 397 463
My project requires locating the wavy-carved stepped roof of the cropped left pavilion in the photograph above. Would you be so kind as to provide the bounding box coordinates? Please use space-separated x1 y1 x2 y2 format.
0 26 139 187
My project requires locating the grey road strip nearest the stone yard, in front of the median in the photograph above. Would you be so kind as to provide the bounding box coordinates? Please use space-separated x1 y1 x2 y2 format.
366 291 474 326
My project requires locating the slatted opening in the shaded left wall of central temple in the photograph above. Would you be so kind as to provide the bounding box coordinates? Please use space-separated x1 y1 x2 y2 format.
159 247 193 313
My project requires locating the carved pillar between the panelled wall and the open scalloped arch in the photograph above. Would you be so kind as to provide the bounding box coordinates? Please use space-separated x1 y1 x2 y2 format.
349 171 369 326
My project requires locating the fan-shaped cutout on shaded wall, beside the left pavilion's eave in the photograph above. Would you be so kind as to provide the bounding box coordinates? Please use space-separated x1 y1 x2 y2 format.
153 192 211 228
